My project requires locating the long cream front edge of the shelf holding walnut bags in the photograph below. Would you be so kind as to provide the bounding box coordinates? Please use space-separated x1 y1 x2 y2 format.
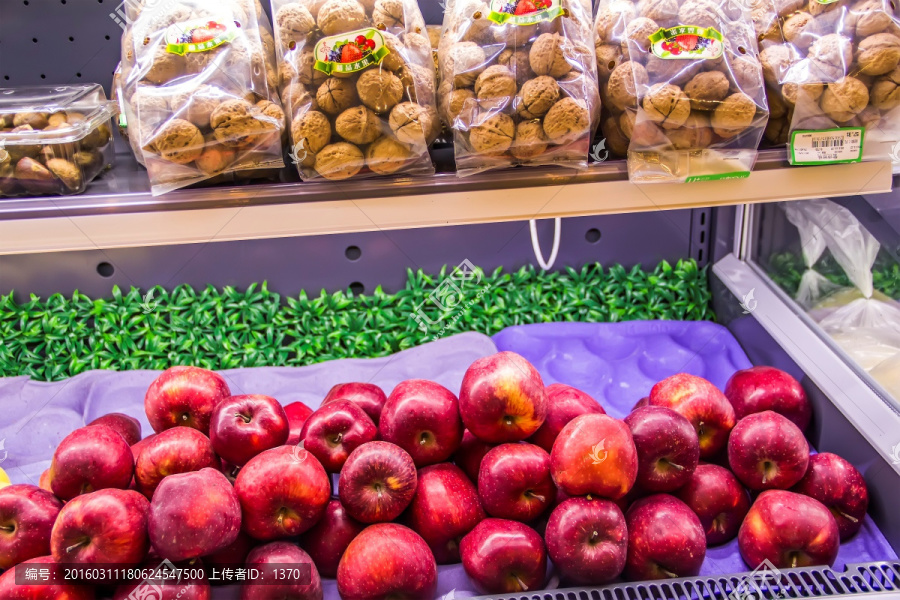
0 150 891 254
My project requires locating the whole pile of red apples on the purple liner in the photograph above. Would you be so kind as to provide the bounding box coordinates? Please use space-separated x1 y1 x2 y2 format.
0 352 868 600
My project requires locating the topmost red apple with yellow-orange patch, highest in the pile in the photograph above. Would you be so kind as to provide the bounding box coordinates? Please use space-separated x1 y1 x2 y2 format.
459 352 547 444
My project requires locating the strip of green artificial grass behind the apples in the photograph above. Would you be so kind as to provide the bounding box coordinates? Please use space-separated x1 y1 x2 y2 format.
0 261 715 381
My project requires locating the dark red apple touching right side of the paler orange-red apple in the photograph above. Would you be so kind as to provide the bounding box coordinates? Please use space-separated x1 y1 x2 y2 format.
625 406 700 492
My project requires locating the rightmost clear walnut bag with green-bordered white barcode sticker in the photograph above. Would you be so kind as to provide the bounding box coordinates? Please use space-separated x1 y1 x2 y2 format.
760 0 900 164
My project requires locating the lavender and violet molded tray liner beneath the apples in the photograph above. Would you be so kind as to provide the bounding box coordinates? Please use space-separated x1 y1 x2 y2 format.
0 321 896 600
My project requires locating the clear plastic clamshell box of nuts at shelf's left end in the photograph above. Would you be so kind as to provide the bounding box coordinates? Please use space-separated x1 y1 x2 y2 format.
0 84 115 197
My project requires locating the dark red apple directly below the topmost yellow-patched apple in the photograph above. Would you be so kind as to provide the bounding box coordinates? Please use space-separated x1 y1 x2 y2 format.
478 444 556 522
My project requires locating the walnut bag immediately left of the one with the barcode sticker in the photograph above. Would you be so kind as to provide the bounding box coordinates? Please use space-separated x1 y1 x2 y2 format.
594 0 774 182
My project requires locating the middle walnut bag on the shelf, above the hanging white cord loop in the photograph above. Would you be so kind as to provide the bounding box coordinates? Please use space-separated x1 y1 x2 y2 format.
438 0 600 177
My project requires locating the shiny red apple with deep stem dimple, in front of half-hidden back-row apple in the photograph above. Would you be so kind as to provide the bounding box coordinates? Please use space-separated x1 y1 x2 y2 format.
300 400 378 473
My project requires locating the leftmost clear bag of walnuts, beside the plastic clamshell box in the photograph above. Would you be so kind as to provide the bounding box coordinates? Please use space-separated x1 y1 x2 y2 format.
121 0 285 195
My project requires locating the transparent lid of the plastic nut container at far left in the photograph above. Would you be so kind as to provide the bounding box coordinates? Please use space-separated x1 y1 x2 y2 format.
0 83 114 145
